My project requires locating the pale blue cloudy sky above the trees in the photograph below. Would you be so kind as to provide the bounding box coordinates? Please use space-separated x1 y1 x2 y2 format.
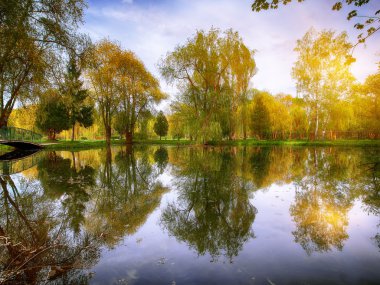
82 0 380 104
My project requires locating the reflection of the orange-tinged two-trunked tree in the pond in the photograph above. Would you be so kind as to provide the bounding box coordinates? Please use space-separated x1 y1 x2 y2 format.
90 147 167 245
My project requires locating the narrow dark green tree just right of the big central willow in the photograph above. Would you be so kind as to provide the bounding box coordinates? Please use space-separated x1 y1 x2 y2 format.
251 95 270 139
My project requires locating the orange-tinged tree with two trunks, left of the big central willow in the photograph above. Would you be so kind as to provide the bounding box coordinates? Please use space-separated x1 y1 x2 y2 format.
87 40 166 145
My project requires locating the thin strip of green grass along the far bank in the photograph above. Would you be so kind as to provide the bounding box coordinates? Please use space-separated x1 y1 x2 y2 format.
41 139 380 150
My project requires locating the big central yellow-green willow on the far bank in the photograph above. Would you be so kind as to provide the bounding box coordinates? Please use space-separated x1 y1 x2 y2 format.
160 29 256 140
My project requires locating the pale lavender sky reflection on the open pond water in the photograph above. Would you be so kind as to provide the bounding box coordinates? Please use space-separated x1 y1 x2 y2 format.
88 151 380 284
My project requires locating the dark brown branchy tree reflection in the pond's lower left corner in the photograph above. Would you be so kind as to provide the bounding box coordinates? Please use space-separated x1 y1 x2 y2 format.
0 176 100 284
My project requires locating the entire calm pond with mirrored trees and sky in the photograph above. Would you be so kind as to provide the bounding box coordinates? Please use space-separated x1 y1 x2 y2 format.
0 146 380 284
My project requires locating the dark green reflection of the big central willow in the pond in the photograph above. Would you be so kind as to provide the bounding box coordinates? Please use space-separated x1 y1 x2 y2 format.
161 149 256 261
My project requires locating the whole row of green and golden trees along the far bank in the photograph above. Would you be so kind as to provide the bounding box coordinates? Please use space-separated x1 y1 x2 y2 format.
0 7 380 144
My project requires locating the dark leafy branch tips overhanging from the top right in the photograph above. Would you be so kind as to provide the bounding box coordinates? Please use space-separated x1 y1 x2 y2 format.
252 0 380 43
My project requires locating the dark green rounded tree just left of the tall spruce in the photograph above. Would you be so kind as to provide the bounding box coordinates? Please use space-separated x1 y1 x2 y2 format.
36 89 70 140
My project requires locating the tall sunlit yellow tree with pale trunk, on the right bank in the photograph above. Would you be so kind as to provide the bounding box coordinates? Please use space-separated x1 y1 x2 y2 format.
292 29 353 138
